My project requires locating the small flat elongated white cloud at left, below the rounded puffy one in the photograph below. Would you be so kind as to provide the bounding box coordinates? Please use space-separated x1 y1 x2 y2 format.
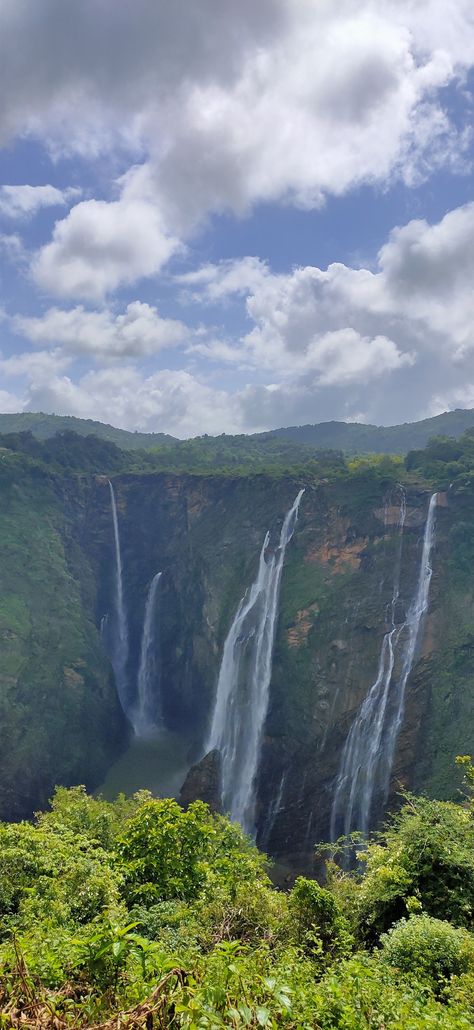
12 301 186 362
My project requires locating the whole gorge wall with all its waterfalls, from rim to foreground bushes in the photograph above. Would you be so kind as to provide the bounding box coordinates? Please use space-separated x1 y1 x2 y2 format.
0 428 474 870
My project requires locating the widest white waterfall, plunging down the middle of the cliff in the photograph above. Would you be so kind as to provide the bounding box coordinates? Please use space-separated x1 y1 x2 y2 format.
207 490 304 833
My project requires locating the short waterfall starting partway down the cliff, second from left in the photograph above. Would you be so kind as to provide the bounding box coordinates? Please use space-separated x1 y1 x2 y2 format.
132 573 162 736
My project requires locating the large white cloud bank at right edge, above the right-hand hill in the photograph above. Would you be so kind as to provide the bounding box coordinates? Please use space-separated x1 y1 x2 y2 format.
188 204 474 383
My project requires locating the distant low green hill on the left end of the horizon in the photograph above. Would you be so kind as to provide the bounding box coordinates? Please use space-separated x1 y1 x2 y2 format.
0 411 175 450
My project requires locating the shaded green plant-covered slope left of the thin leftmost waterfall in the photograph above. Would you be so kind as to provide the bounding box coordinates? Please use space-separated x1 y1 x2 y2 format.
0 453 123 818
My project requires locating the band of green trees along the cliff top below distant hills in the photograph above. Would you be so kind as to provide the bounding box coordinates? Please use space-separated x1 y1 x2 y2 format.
0 428 474 492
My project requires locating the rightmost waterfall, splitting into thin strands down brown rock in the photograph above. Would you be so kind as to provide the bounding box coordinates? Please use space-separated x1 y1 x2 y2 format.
331 488 437 840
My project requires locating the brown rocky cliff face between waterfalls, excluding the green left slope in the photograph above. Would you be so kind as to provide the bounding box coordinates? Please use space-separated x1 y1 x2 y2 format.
82 474 474 867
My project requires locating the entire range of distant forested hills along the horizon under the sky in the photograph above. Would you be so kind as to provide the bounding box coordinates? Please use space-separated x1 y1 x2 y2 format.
0 408 474 457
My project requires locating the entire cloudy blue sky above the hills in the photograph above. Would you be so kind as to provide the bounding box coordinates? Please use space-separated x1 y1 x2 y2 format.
0 0 474 437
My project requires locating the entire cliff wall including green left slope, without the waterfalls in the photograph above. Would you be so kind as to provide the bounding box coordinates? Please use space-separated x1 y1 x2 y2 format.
0 463 474 868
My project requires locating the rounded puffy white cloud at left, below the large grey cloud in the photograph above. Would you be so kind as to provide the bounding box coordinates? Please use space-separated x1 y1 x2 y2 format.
31 196 178 301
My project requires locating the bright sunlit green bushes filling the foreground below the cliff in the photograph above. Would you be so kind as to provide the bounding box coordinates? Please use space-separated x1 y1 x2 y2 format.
0 759 474 1030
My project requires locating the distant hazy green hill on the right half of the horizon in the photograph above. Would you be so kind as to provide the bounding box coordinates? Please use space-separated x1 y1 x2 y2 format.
259 408 474 454
